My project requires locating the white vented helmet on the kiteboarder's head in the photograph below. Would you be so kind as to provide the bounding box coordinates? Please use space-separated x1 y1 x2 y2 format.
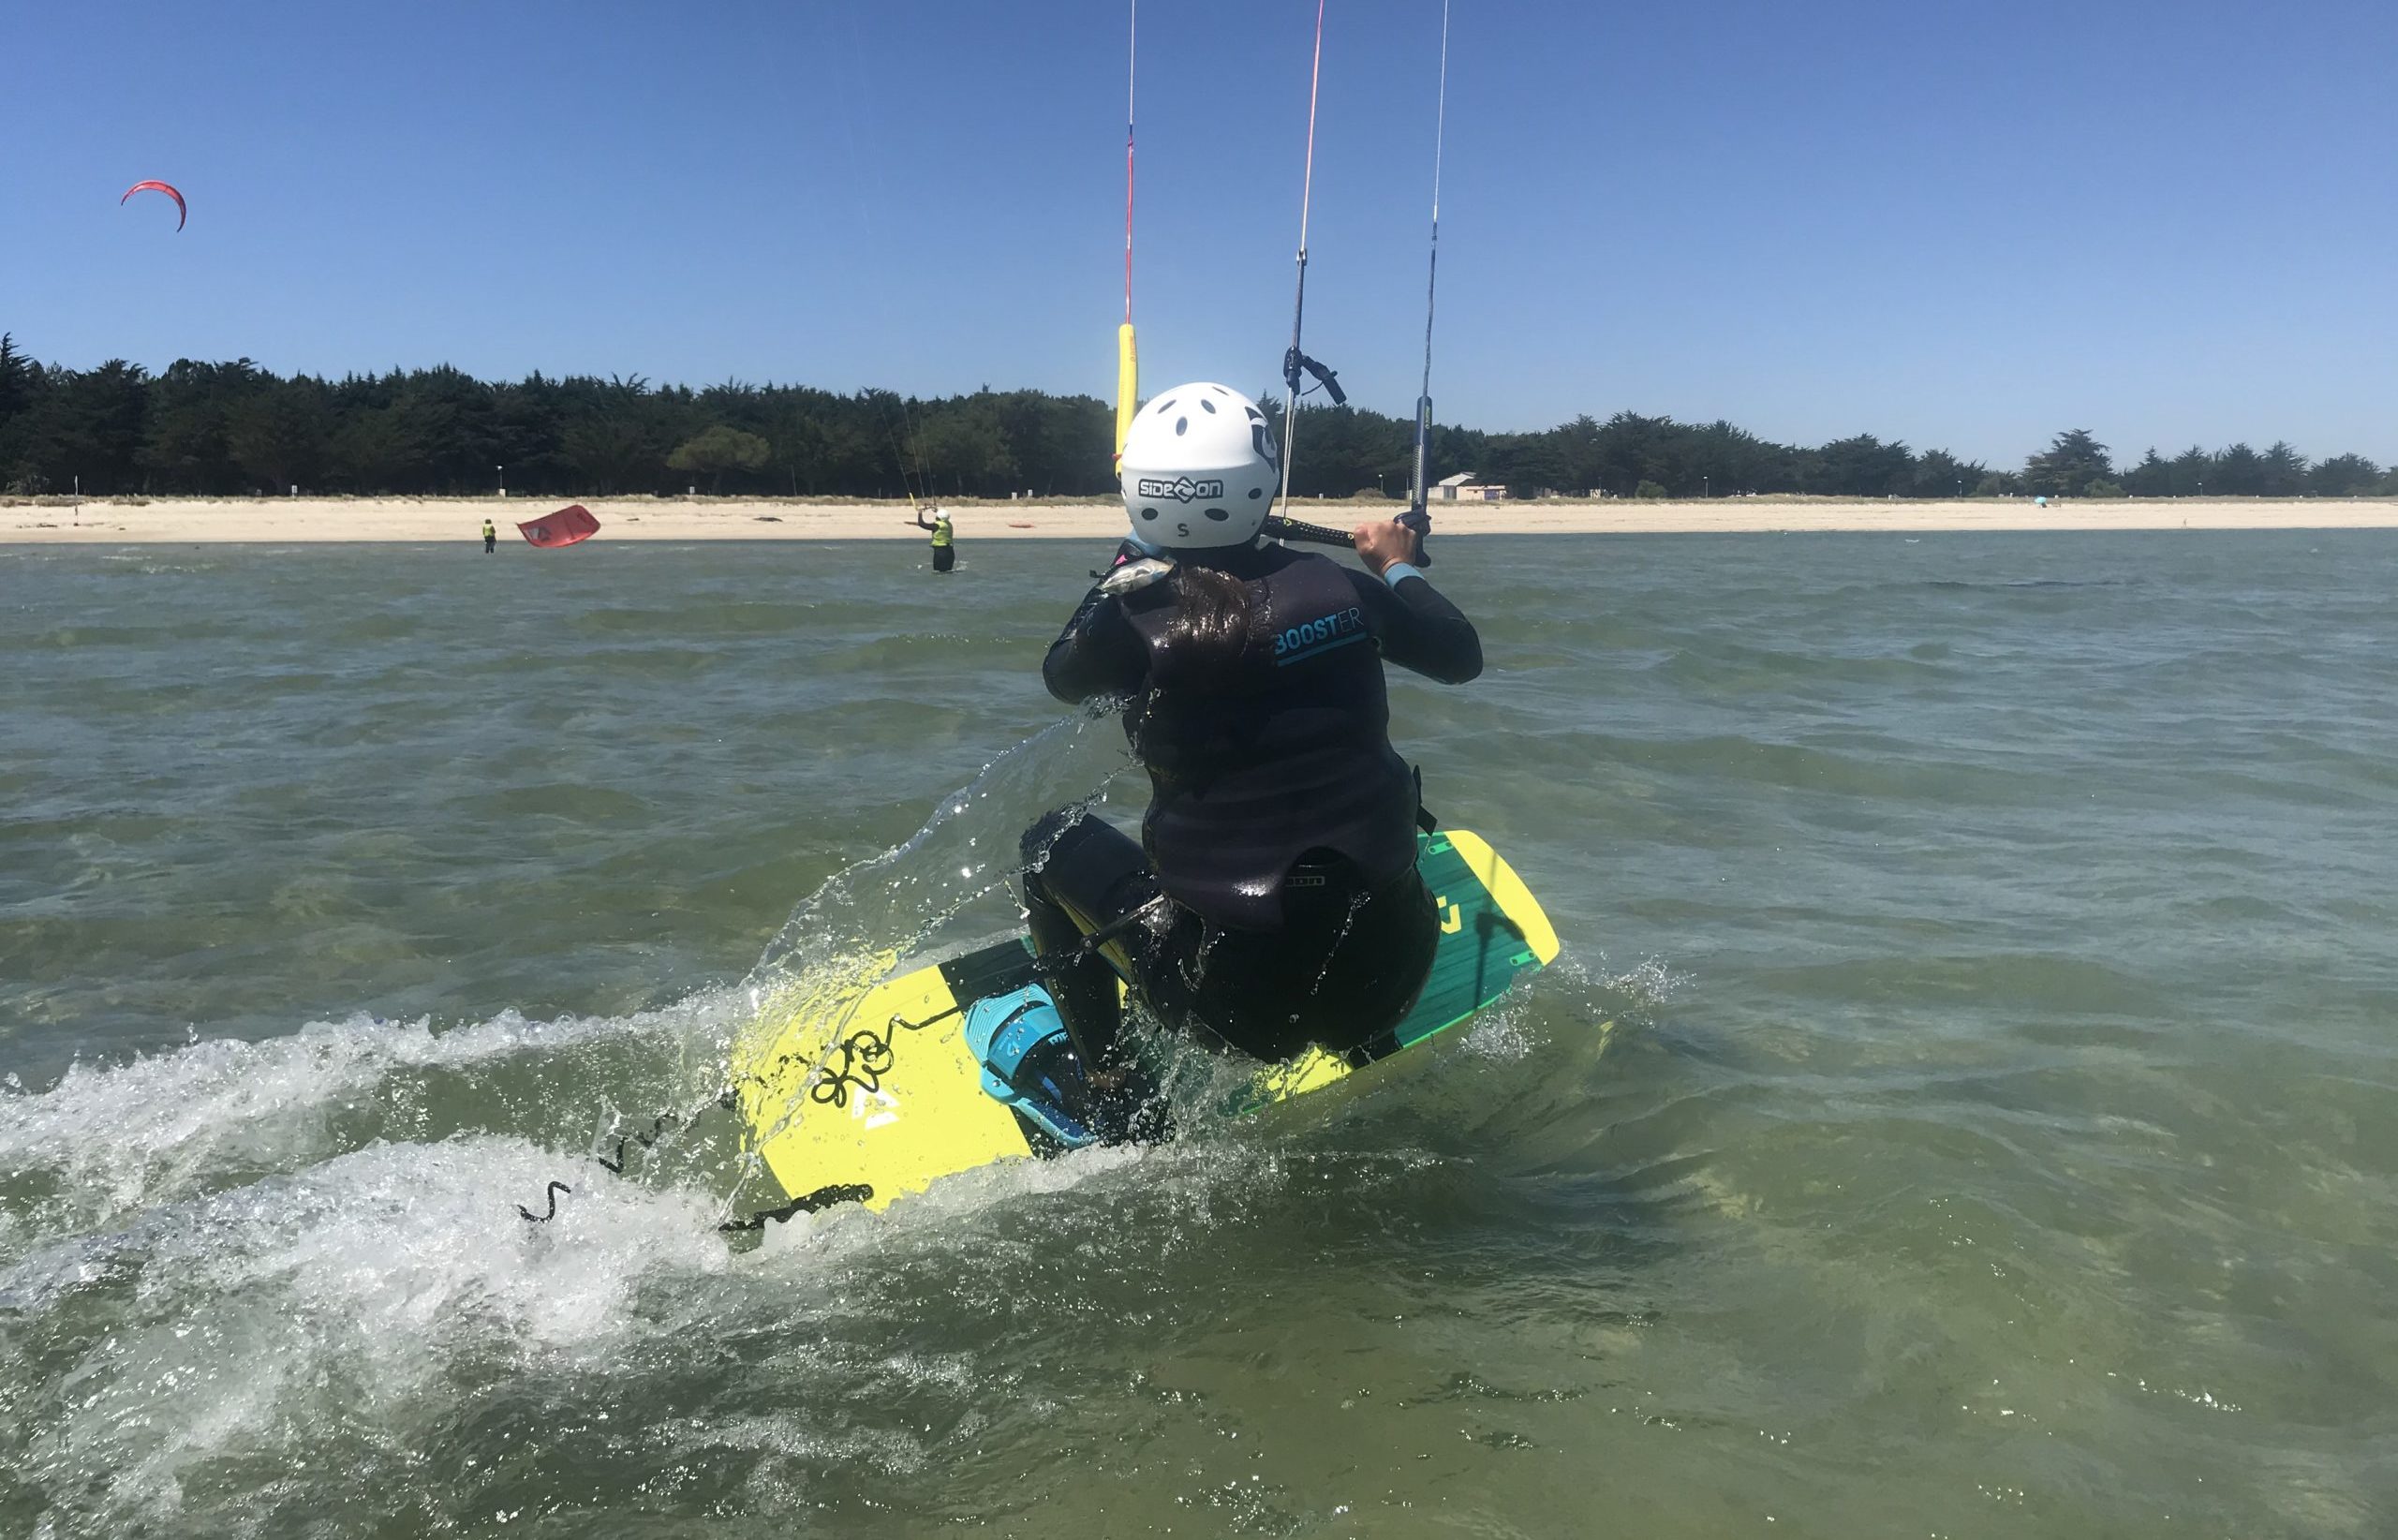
1120 381 1283 552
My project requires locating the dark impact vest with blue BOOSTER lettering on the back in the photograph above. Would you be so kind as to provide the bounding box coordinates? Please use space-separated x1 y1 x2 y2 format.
1125 547 1414 931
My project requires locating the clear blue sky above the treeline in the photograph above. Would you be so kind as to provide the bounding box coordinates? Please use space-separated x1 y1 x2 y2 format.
0 0 2398 463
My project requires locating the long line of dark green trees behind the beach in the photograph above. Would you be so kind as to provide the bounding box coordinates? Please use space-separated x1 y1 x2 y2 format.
0 336 2398 499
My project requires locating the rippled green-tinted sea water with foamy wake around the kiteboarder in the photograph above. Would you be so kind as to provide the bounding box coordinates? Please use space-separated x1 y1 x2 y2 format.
0 532 2398 1537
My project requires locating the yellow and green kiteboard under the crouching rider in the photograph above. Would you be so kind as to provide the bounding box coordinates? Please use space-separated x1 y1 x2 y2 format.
733 830 1556 1211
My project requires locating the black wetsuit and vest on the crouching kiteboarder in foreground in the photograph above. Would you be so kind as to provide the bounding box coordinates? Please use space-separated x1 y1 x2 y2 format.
1024 547 1482 1065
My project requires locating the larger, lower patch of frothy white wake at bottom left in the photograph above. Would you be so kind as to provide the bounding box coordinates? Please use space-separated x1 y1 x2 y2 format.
0 1137 729 1533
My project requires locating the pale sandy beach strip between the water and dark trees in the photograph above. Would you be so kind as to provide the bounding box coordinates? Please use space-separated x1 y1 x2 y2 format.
0 496 2398 544
